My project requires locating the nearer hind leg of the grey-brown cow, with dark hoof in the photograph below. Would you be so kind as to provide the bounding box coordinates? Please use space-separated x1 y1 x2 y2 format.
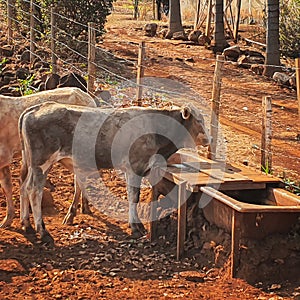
27 167 54 245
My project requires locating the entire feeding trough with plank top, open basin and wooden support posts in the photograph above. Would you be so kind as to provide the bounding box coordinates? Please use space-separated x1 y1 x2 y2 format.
151 153 300 277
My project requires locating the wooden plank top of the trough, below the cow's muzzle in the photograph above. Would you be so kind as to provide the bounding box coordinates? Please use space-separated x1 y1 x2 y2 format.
161 150 282 192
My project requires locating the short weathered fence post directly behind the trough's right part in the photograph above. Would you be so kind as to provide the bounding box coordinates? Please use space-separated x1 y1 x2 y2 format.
261 96 272 174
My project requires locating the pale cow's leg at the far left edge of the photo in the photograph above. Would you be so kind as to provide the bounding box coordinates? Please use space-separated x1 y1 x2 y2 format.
0 166 15 227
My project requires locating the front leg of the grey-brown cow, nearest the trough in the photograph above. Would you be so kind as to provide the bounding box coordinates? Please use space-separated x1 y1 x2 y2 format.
126 174 146 237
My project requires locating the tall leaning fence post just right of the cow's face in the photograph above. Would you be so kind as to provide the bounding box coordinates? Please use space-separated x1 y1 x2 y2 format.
208 55 225 160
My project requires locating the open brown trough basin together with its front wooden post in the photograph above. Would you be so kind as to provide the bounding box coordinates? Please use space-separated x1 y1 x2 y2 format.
201 187 300 277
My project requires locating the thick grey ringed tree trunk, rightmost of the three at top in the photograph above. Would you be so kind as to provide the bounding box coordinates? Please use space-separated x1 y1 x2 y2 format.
263 0 280 77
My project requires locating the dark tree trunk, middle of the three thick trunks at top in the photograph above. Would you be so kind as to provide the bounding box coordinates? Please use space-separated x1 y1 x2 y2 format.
212 0 229 53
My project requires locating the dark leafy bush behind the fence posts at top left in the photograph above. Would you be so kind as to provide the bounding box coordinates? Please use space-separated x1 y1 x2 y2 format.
5 0 113 46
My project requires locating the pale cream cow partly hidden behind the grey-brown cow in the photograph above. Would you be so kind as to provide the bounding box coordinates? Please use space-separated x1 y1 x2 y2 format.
0 88 97 227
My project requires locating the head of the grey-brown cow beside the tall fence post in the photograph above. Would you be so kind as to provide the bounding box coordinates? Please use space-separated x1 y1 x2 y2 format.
181 104 211 146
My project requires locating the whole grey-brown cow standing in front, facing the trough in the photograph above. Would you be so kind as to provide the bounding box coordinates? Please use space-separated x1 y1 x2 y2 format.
19 103 208 243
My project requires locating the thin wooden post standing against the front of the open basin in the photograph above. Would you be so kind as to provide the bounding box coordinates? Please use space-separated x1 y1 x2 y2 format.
231 209 241 278
